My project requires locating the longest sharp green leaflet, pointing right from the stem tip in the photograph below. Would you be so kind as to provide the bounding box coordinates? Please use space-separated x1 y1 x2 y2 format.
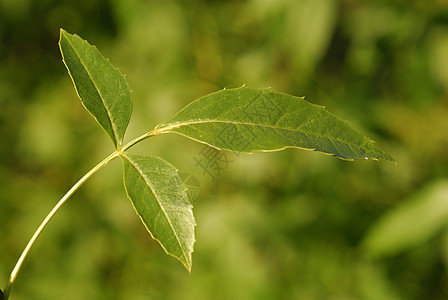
156 87 393 160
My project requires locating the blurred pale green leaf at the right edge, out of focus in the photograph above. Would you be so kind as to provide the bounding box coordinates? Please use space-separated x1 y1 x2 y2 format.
363 181 448 257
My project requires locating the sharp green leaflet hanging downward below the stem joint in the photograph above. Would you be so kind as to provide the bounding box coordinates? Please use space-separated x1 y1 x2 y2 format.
121 153 196 271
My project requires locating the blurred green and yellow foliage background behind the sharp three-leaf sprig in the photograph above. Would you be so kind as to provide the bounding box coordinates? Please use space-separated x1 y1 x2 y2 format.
0 0 448 300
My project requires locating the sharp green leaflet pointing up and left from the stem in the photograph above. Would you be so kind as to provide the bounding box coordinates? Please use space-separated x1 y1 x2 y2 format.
59 29 132 149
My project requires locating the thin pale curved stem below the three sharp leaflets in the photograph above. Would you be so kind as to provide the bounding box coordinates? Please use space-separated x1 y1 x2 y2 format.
3 152 120 300
